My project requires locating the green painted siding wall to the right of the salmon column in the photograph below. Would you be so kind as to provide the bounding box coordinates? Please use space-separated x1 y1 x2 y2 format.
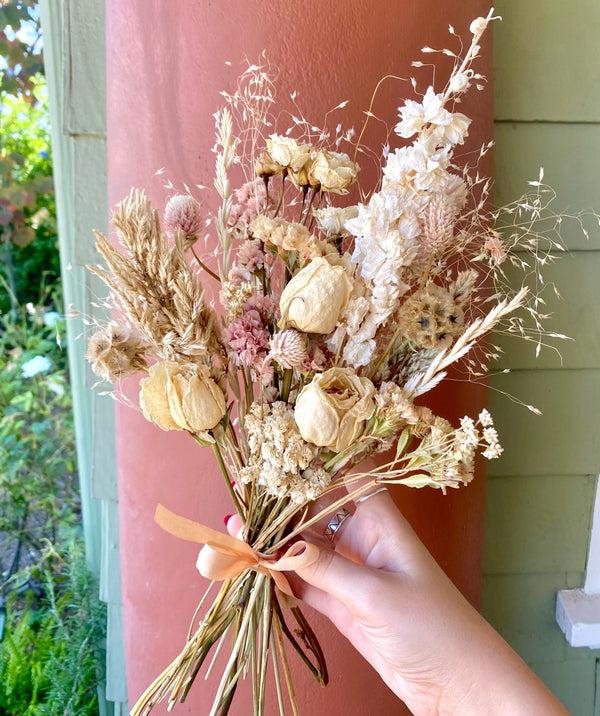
483 0 600 716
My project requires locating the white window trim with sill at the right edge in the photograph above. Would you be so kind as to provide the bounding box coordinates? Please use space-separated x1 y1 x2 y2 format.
556 477 600 649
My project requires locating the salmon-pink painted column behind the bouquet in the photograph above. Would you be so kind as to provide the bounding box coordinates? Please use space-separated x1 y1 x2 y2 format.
107 0 492 716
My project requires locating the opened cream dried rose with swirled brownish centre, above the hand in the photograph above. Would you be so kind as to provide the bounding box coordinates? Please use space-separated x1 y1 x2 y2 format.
294 368 376 452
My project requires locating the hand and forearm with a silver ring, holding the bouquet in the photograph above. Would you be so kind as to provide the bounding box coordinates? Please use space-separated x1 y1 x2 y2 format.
227 492 568 716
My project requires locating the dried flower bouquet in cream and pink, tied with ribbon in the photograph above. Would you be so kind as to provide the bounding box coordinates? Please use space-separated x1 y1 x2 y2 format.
88 11 583 716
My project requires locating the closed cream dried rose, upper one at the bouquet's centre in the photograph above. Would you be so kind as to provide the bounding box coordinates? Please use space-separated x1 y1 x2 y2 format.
279 257 352 333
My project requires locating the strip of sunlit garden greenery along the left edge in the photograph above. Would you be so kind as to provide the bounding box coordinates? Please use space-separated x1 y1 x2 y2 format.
0 0 105 716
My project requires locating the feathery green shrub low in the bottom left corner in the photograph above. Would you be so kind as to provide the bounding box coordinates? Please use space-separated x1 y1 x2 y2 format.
0 537 105 716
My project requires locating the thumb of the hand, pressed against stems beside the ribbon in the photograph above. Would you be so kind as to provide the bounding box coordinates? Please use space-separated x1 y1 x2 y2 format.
296 548 379 613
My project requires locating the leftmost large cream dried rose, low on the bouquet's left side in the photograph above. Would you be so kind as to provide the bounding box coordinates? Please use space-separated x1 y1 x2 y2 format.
140 361 226 433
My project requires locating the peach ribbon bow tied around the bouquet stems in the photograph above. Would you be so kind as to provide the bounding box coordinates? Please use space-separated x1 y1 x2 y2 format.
154 505 319 597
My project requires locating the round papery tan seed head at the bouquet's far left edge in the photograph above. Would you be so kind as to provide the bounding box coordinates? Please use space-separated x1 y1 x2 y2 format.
85 323 148 383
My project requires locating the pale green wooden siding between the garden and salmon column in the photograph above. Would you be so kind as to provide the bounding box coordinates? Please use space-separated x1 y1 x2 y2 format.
41 0 128 716
